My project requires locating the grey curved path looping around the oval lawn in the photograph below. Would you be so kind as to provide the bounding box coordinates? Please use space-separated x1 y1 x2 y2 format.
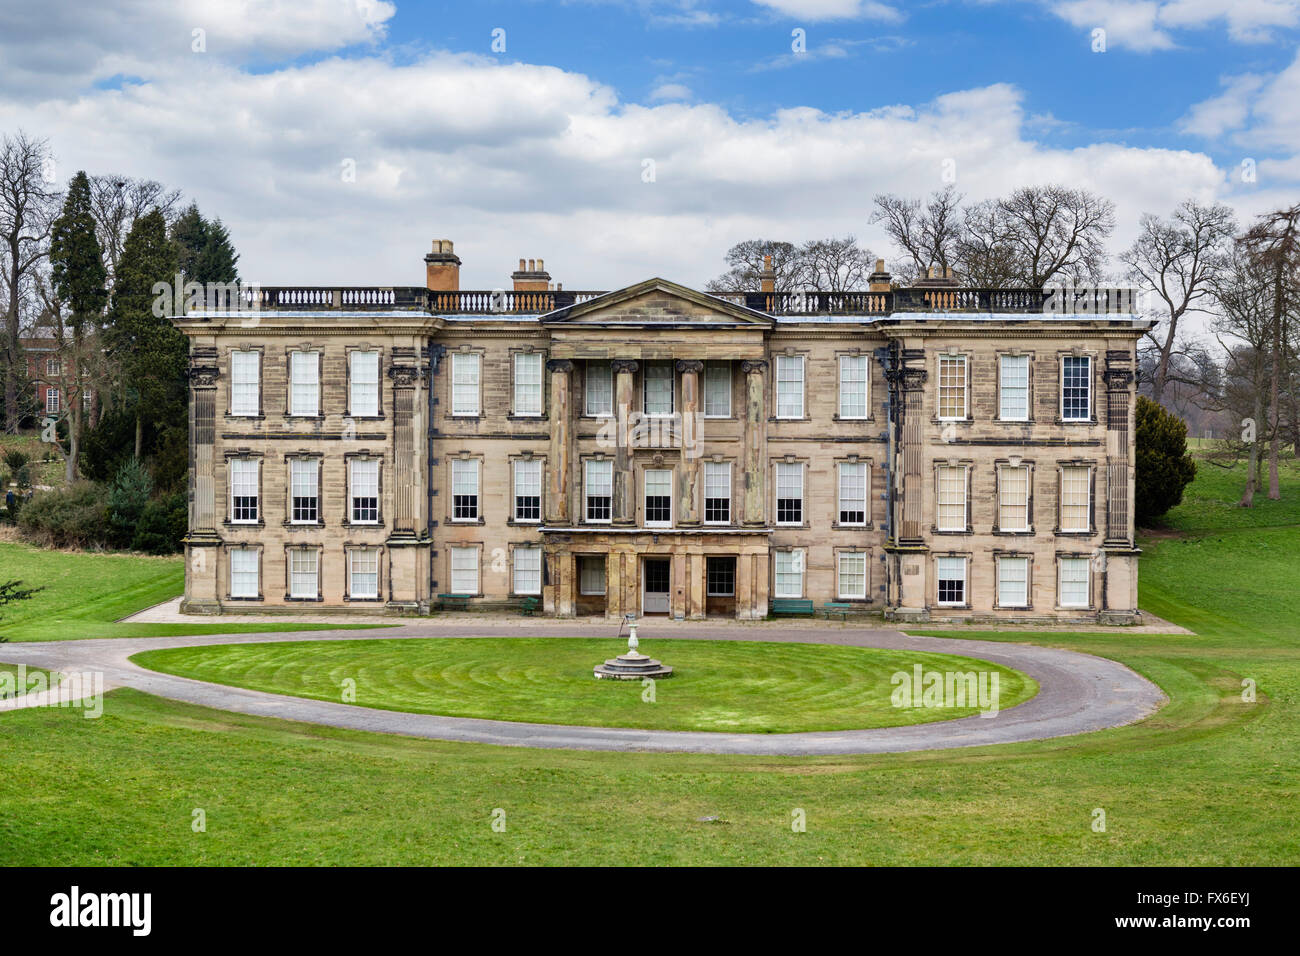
0 622 1166 756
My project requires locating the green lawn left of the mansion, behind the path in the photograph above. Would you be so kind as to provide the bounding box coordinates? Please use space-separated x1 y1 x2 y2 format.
0 541 384 642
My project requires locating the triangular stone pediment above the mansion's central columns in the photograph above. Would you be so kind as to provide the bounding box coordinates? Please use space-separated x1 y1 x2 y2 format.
541 278 774 328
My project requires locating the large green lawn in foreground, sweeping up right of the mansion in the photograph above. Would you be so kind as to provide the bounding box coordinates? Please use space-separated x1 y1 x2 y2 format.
0 457 1300 866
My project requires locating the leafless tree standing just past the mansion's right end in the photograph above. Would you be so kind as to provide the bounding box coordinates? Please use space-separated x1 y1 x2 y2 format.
1119 199 1236 402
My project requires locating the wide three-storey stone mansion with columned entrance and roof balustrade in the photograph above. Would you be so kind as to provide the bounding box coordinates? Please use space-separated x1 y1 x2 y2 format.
173 241 1147 623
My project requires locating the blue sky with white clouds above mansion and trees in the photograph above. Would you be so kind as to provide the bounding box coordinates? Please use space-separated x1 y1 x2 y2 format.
0 0 1300 287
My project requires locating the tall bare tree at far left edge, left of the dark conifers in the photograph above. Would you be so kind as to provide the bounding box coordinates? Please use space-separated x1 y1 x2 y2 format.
0 130 60 432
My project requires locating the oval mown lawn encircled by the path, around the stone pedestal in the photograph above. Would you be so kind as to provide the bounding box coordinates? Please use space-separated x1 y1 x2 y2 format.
131 637 1037 734
